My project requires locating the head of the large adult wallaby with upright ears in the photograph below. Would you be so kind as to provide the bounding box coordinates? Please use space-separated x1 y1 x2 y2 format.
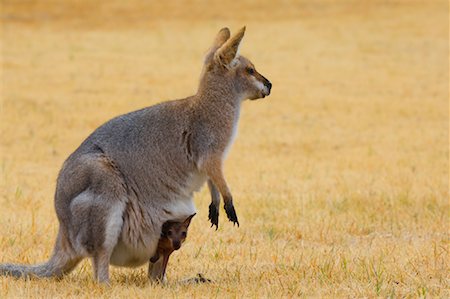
199 27 272 100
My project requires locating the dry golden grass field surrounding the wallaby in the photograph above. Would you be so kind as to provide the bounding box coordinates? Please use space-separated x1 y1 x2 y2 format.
0 0 450 298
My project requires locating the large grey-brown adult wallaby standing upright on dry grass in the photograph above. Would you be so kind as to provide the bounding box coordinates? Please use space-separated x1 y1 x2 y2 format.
0 27 272 282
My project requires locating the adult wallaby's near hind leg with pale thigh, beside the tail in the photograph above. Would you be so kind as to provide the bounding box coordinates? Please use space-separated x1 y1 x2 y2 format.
65 152 127 282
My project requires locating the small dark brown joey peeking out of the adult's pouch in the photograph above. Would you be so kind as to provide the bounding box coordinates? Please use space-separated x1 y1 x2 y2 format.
150 214 195 281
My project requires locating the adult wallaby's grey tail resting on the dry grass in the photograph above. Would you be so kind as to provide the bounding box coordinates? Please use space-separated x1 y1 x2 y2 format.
0 232 81 277
